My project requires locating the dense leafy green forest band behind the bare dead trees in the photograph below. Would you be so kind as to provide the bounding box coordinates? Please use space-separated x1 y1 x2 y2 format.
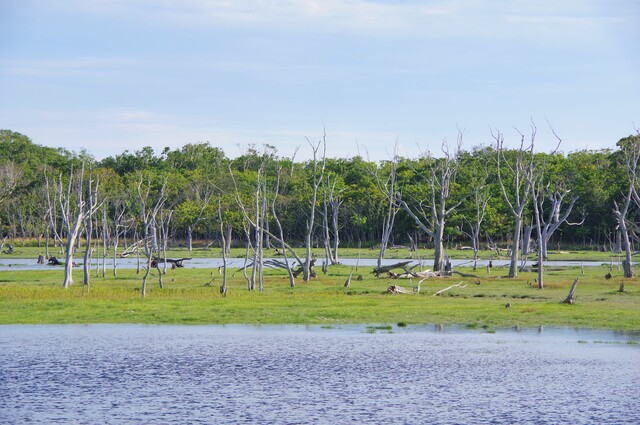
0 130 640 255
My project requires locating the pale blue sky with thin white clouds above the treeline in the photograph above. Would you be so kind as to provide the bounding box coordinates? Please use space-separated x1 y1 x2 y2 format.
0 0 640 160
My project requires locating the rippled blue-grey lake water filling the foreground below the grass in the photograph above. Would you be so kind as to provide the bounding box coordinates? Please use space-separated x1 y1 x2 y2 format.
0 325 640 424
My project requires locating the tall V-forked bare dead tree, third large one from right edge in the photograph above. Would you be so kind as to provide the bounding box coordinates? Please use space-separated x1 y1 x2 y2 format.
491 123 537 278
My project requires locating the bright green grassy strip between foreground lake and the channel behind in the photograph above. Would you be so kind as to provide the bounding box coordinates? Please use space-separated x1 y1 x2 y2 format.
0 252 640 331
